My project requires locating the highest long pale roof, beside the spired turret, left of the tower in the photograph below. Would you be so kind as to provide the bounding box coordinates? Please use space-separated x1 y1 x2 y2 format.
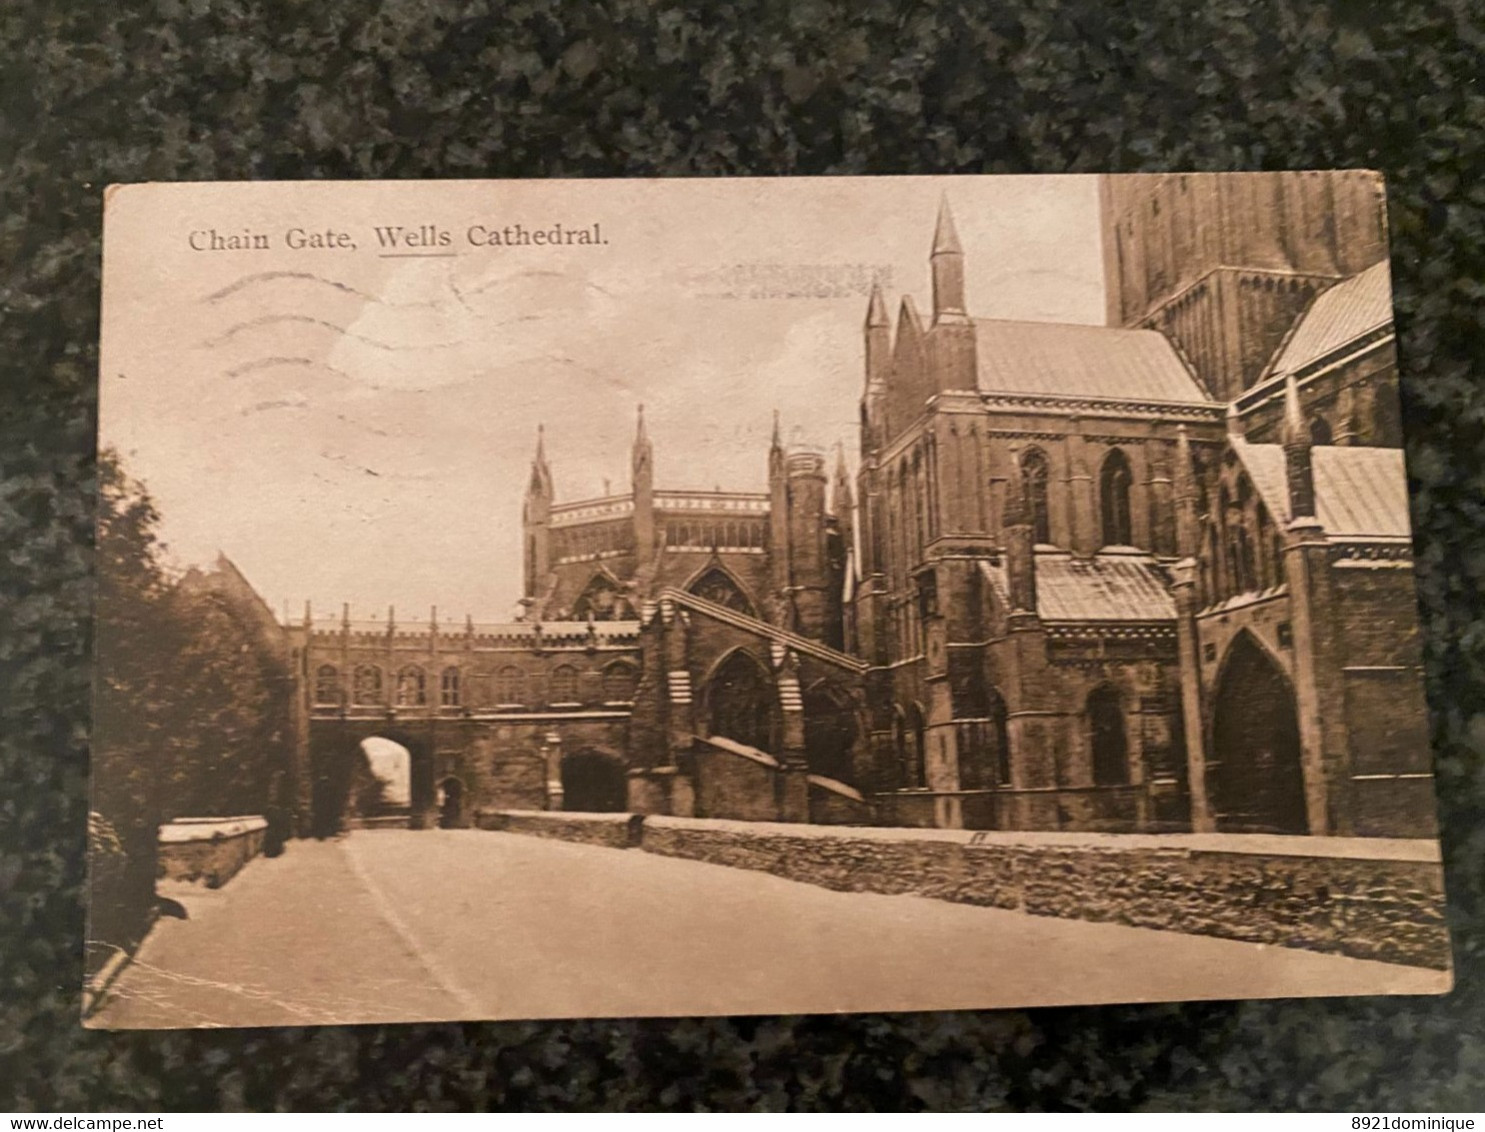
974 318 1210 404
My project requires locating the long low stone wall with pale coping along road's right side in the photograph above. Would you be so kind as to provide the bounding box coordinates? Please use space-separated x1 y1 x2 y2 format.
487 814 1449 969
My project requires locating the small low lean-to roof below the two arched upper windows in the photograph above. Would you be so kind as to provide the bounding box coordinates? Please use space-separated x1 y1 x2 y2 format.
983 550 1176 622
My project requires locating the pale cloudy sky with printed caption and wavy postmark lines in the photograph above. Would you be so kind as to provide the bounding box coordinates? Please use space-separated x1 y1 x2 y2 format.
99 177 1103 622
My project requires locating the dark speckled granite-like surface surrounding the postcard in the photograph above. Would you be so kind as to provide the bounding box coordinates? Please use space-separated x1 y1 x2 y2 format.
0 0 1485 1111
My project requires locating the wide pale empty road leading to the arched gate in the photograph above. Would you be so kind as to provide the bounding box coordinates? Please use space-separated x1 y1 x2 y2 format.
92 830 1446 1028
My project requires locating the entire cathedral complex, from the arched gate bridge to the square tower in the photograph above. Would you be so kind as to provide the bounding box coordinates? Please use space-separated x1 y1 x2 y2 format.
288 172 1433 836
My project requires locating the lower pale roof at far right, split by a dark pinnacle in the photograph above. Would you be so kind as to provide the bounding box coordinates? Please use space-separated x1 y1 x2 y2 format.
1233 440 1412 539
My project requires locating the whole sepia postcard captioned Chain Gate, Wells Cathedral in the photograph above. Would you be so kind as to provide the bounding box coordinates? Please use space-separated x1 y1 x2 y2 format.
85 171 1451 1028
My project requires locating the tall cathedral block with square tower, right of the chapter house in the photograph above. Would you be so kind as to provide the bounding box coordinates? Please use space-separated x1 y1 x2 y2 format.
849 174 1433 836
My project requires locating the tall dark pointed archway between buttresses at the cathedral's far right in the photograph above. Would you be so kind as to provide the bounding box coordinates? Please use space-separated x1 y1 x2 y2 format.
1207 633 1310 833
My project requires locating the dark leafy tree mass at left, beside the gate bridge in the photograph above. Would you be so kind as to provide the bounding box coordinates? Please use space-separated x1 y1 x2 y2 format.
89 452 294 961
